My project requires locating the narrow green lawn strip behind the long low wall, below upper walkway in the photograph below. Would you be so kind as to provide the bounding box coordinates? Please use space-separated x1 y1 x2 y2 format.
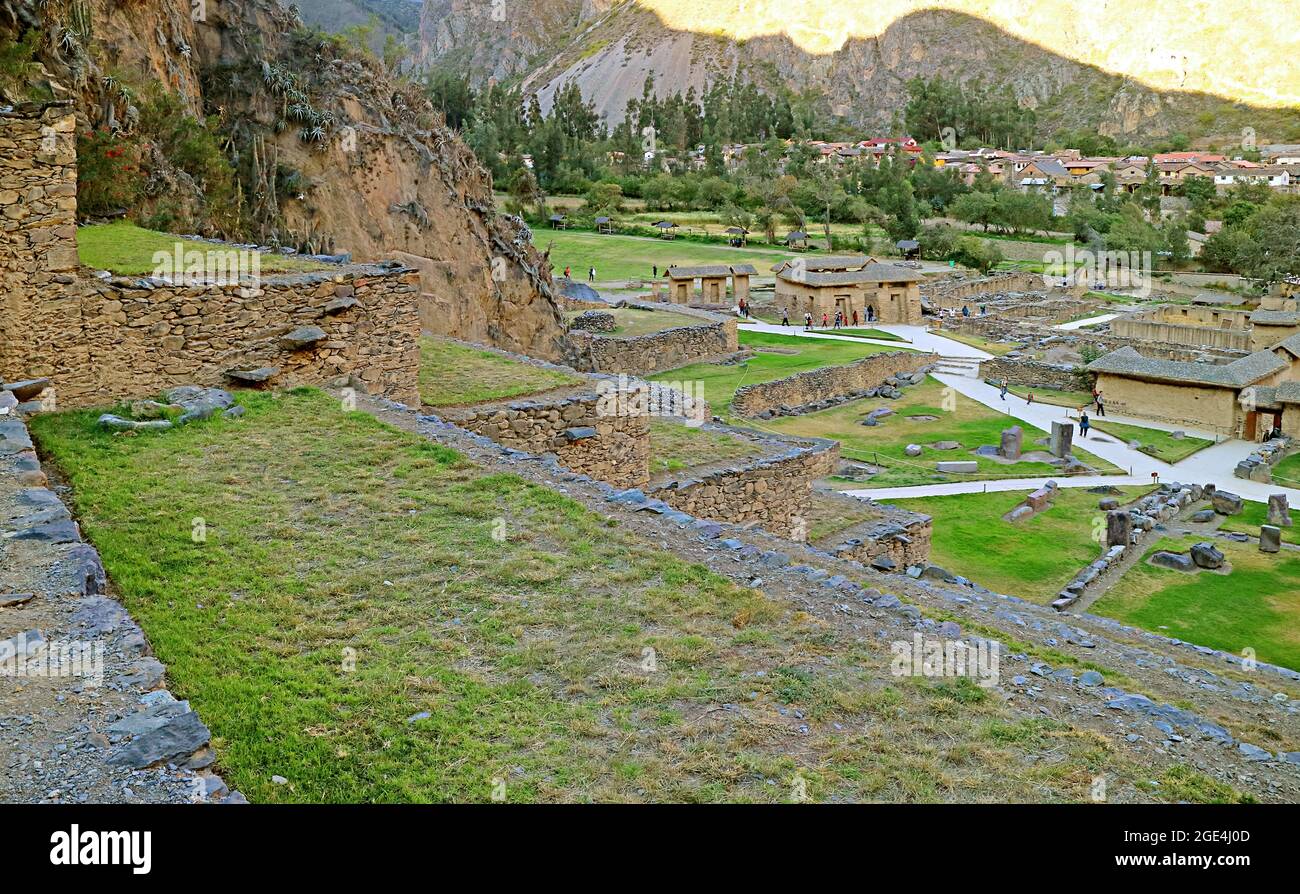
650 329 907 417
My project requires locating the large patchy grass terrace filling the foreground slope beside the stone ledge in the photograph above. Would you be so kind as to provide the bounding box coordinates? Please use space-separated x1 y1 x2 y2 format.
25 390 1201 803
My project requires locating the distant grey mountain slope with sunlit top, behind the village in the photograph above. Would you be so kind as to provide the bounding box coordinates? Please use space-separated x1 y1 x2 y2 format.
419 0 1300 136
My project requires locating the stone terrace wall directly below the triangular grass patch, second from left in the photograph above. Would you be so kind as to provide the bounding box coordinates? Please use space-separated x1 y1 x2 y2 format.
439 392 650 487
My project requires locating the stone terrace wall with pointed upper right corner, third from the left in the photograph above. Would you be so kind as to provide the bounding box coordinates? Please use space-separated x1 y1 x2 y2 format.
650 441 840 538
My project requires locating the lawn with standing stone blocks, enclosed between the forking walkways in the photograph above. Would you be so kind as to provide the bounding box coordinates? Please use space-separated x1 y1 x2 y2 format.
764 378 1119 487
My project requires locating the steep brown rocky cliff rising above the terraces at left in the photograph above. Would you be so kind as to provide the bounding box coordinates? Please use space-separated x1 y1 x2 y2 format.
0 0 563 357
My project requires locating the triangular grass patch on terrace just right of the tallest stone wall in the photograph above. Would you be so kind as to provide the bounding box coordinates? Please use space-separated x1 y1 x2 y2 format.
420 335 584 407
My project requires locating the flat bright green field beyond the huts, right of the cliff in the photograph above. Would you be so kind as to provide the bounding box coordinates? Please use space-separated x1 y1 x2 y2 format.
533 230 796 282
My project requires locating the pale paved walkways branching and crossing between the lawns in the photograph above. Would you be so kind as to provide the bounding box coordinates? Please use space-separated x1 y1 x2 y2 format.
745 322 1300 504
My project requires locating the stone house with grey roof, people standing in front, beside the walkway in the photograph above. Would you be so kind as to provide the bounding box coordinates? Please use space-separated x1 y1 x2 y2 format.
772 255 924 325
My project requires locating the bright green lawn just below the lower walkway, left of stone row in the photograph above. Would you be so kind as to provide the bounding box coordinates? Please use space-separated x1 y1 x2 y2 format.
889 487 1159 602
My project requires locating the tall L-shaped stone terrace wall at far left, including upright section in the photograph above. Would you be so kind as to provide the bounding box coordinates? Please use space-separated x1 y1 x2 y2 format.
0 105 420 407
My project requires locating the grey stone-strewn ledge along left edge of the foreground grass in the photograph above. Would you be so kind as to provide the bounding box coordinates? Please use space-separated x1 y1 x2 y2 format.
0 404 246 803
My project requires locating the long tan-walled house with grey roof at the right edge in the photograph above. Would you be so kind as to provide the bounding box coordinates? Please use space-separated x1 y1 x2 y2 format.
1088 335 1300 441
